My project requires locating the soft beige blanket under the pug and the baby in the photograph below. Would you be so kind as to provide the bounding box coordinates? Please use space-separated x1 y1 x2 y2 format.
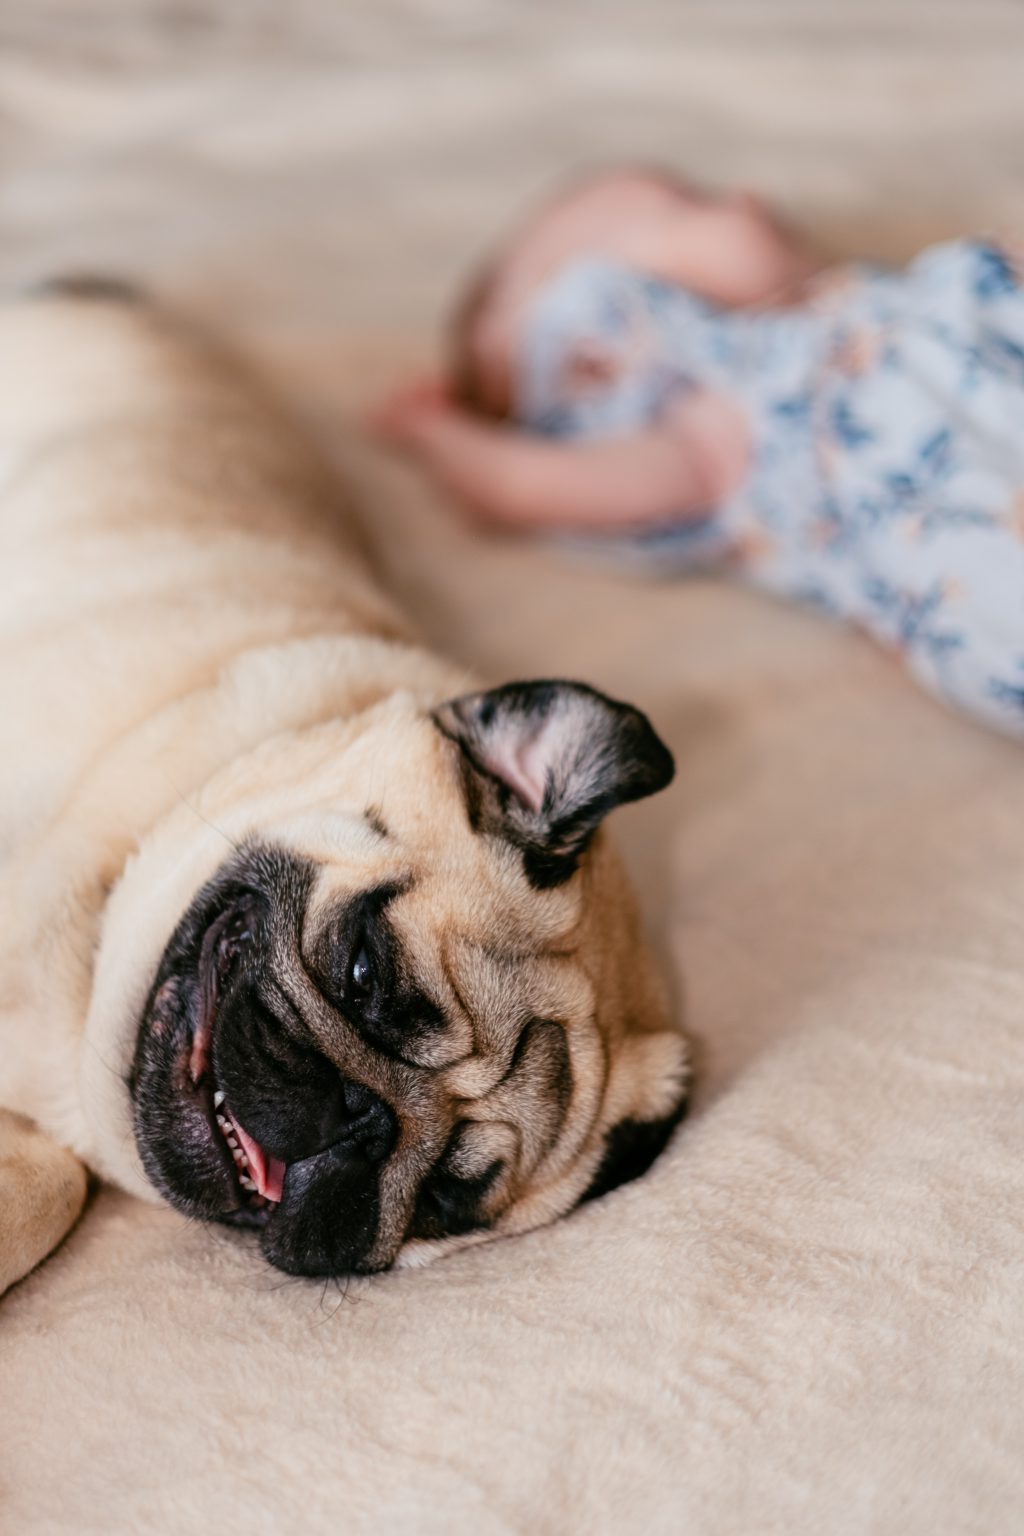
0 0 1024 1536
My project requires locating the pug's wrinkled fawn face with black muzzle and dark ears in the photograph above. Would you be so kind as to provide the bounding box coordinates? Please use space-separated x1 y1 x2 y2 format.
130 684 686 1275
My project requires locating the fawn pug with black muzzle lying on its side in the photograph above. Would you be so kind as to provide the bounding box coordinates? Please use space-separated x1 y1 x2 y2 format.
0 283 688 1289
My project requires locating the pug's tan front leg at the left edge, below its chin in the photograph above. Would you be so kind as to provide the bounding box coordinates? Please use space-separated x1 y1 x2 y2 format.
0 1109 88 1295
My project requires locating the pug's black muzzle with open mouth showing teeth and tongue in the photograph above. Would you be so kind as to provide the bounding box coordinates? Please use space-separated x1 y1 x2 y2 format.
130 854 398 1275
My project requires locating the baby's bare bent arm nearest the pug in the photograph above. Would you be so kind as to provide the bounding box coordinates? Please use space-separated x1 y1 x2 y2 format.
376 387 748 530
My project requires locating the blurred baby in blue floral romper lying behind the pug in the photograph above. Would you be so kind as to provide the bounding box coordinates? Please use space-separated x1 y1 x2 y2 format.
375 170 1024 736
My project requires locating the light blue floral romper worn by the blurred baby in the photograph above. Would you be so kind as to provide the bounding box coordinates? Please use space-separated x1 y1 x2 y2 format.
517 241 1024 736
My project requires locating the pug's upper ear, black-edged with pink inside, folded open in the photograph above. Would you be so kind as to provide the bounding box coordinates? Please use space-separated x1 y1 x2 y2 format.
433 682 674 891
